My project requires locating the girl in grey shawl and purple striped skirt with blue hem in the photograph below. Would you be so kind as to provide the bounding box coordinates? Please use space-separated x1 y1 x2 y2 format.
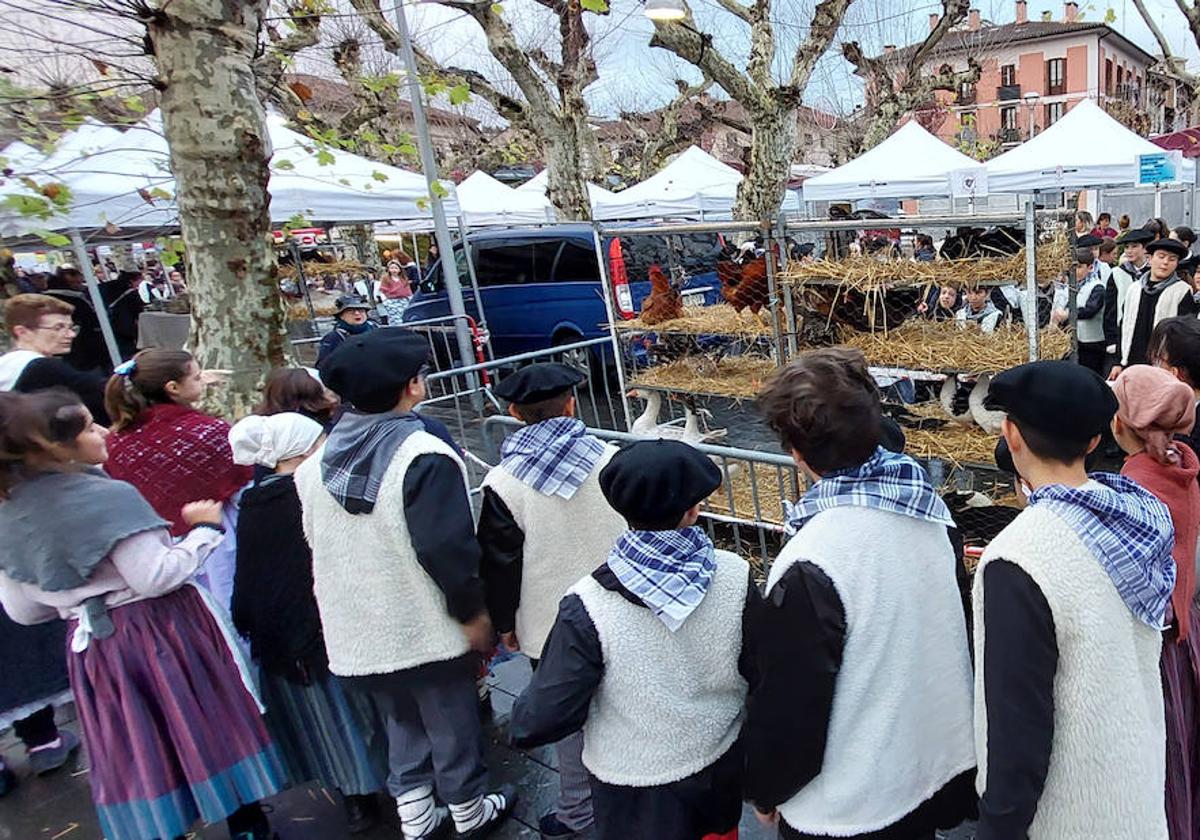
0 391 282 840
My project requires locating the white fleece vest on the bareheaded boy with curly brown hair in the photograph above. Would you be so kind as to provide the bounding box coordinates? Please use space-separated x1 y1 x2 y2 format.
767 506 974 836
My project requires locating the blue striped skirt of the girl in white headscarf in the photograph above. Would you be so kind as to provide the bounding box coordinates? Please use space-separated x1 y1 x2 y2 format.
259 673 388 796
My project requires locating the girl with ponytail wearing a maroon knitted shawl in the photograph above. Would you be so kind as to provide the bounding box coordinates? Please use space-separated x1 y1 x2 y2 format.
104 350 253 610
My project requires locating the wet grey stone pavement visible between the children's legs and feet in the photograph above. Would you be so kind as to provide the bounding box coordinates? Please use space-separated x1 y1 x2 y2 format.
0 656 973 840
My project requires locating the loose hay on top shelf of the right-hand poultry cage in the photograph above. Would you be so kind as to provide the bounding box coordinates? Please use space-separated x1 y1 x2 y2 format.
780 236 1070 292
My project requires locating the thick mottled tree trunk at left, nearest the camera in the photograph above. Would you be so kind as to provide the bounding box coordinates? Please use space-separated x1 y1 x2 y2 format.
148 0 283 416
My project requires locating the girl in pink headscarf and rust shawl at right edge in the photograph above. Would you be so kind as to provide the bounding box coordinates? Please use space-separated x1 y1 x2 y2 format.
1112 365 1200 840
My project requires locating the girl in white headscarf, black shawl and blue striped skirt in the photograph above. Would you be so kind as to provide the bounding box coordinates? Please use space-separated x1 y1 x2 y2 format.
229 412 388 833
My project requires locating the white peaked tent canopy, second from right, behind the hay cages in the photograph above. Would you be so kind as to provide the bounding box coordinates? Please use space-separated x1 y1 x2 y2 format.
803 120 980 202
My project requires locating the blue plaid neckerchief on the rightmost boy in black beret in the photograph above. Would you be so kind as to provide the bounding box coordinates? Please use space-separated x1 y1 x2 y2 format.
1030 473 1175 630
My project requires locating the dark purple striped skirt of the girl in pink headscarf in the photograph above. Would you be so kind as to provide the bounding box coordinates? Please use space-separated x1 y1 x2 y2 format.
1159 605 1200 840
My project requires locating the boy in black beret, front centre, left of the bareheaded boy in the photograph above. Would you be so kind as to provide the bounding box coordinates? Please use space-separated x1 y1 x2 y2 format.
509 440 756 840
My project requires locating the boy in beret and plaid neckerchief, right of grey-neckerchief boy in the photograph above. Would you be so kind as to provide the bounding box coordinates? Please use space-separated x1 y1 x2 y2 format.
478 362 625 838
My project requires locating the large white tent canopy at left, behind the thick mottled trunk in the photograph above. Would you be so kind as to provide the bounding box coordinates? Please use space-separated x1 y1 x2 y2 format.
0 113 458 235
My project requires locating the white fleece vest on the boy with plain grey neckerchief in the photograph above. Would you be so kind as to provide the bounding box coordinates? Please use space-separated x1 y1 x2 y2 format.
295 431 468 677
